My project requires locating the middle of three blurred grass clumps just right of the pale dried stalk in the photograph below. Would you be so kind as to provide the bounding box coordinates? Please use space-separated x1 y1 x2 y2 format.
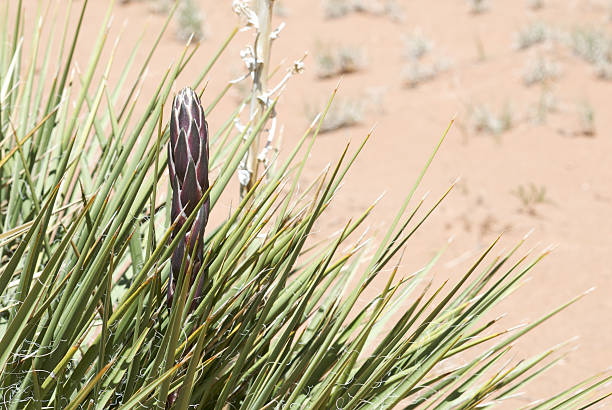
317 45 366 78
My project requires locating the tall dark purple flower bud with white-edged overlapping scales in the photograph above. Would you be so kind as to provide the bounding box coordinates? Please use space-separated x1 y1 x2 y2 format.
168 87 210 306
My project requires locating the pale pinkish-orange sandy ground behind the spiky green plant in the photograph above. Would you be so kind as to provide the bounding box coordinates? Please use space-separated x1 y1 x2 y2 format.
16 0 612 404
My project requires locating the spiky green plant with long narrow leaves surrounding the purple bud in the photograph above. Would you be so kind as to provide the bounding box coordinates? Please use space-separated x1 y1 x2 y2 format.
0 0 610 409
